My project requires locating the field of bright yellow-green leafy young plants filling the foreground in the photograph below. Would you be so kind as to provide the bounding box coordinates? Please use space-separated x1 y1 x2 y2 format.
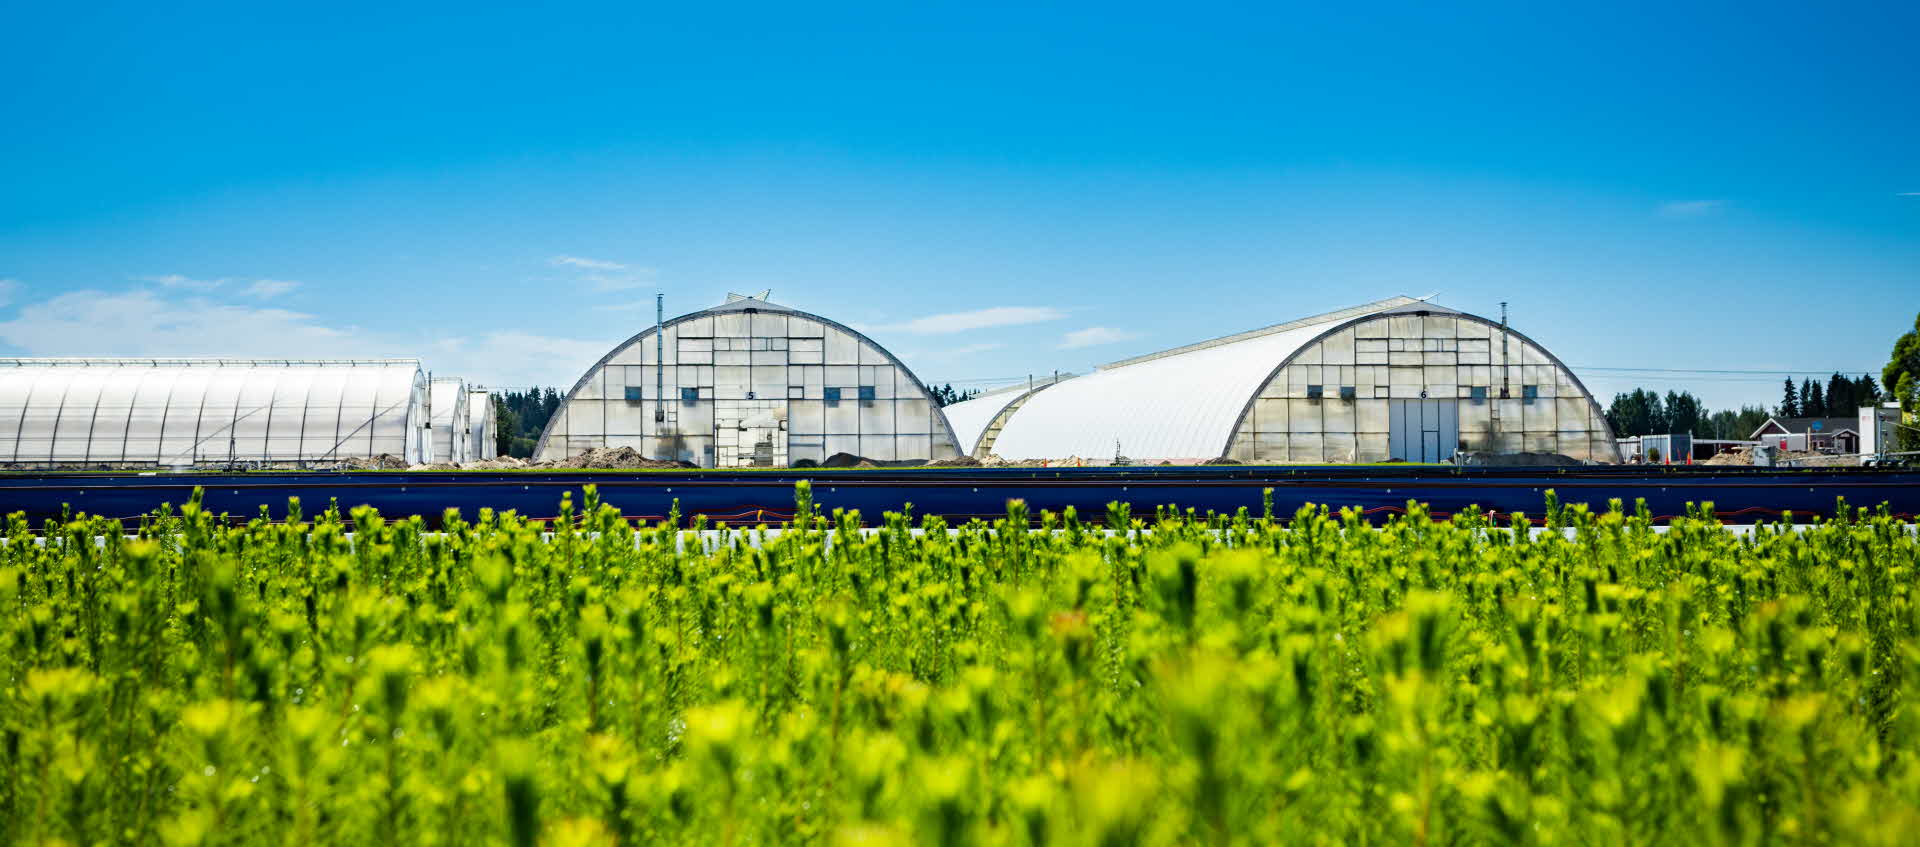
0 482 1920 845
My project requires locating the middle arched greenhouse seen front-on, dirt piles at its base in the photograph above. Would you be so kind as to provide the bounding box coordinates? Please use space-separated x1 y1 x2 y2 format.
534 294 958 467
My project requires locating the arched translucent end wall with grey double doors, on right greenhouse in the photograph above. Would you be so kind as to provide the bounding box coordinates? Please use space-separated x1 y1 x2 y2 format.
1227 311 1620 463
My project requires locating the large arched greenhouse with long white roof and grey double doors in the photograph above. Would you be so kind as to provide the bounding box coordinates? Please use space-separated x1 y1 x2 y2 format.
947 298 1619 463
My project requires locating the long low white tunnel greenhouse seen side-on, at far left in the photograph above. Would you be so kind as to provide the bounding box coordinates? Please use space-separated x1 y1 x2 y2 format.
0 359 426 467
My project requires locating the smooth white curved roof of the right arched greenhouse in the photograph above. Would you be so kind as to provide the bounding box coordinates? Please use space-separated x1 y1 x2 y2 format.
990 298 1452 459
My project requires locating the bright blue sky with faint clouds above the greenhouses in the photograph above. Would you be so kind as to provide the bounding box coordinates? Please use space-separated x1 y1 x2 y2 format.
0 2 1920 407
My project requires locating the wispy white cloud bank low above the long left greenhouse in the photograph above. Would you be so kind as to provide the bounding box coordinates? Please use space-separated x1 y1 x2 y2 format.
0 288 612 386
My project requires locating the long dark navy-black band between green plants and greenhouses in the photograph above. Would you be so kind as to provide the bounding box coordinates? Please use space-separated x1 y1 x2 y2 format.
0 465 1920 528
